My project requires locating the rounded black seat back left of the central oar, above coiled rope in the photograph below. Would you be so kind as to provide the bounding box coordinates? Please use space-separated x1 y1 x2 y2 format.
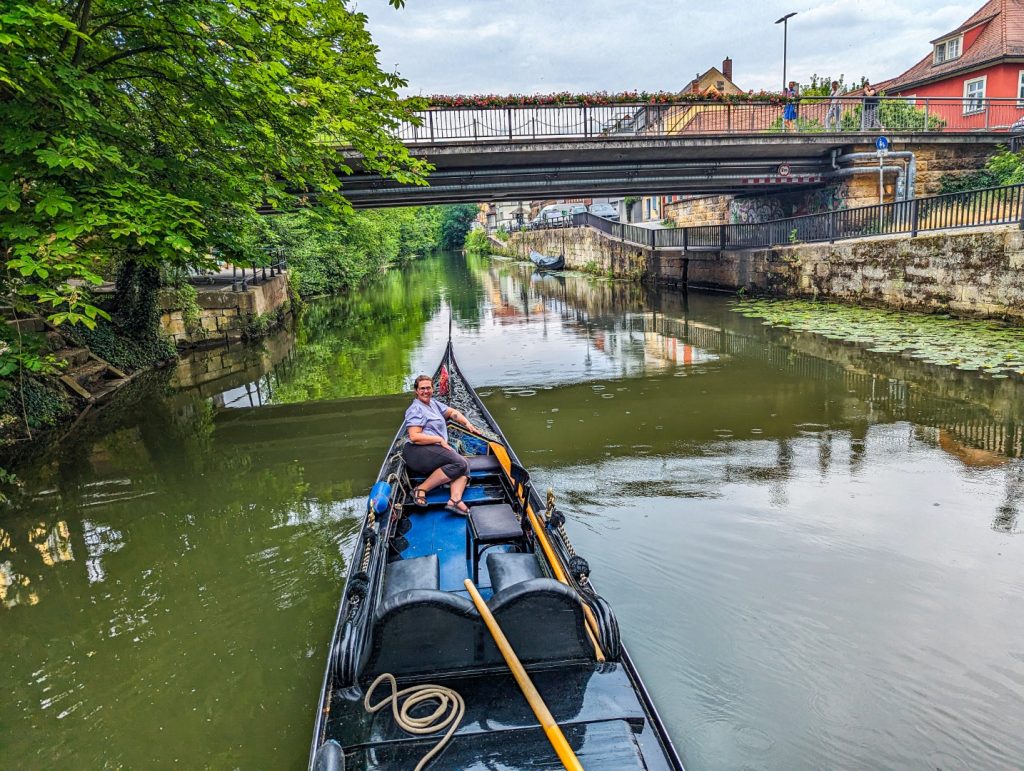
359 589 501 683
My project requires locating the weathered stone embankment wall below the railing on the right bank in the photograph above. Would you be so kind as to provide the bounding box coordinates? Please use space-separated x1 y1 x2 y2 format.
507 225 1024 324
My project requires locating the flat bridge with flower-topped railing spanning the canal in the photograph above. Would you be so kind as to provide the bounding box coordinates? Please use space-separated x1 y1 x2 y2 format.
339 97 1024 208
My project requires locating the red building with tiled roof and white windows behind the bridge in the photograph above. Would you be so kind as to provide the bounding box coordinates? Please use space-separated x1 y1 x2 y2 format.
879 0 1024 127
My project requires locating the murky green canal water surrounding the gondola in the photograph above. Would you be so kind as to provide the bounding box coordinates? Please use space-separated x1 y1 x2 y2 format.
0 250 1024 771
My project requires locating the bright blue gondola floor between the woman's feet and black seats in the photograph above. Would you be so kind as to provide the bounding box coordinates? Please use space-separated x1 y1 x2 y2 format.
401 499 512 599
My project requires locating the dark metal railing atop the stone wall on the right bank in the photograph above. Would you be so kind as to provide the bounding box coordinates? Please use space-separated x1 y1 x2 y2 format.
565 184 1024 252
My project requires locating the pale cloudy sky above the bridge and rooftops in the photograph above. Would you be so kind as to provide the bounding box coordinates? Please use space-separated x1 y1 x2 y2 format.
354 0 983 95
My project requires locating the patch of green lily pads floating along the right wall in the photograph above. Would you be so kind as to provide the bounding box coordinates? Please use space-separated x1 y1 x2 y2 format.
732 299 1024 378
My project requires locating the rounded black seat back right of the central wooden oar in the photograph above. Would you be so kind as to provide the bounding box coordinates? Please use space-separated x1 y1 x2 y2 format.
487 579 594 661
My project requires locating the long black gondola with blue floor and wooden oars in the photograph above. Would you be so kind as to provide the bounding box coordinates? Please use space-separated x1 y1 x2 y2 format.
309 341 683 771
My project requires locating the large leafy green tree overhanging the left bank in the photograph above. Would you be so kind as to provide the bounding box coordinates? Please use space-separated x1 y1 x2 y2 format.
0 0 428 326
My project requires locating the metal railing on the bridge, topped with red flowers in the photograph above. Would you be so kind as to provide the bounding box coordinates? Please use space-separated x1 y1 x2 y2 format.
396 96 1024 144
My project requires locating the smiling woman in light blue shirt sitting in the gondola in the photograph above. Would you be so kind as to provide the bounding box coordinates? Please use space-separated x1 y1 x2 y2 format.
401 375 476 514
